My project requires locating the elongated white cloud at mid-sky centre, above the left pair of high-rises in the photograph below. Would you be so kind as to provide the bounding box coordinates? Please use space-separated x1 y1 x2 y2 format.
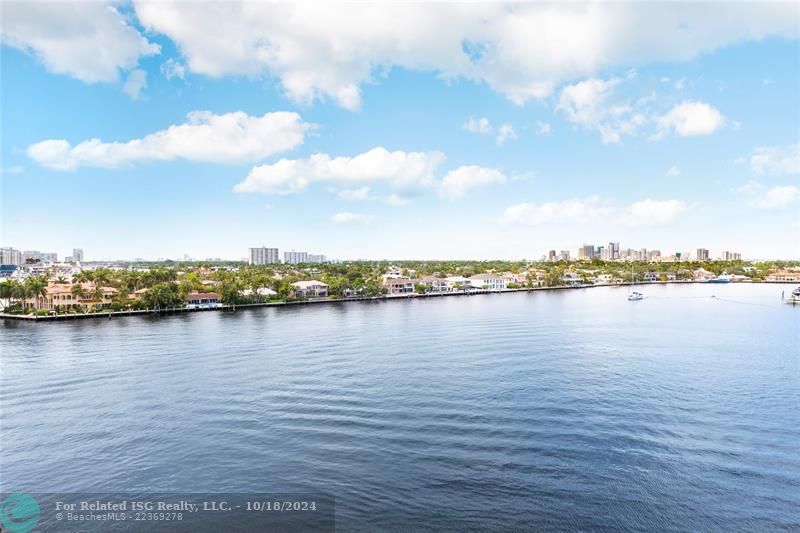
233 147 444 194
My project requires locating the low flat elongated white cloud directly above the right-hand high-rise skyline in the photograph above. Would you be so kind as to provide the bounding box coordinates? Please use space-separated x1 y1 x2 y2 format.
500 196 688 225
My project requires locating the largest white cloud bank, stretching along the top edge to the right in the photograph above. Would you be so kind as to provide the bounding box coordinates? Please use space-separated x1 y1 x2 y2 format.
134 0 798 109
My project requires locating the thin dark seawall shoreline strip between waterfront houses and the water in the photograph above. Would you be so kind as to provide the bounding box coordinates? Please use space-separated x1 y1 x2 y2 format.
0 281 796 322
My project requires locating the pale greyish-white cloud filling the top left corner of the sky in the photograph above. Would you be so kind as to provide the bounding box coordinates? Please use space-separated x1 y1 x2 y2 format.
0 2 160 83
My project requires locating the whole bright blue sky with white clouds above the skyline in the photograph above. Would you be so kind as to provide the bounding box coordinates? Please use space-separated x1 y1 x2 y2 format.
0 1 800 260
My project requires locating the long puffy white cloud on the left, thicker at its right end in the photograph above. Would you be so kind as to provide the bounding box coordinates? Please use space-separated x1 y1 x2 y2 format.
27 111 314 170
